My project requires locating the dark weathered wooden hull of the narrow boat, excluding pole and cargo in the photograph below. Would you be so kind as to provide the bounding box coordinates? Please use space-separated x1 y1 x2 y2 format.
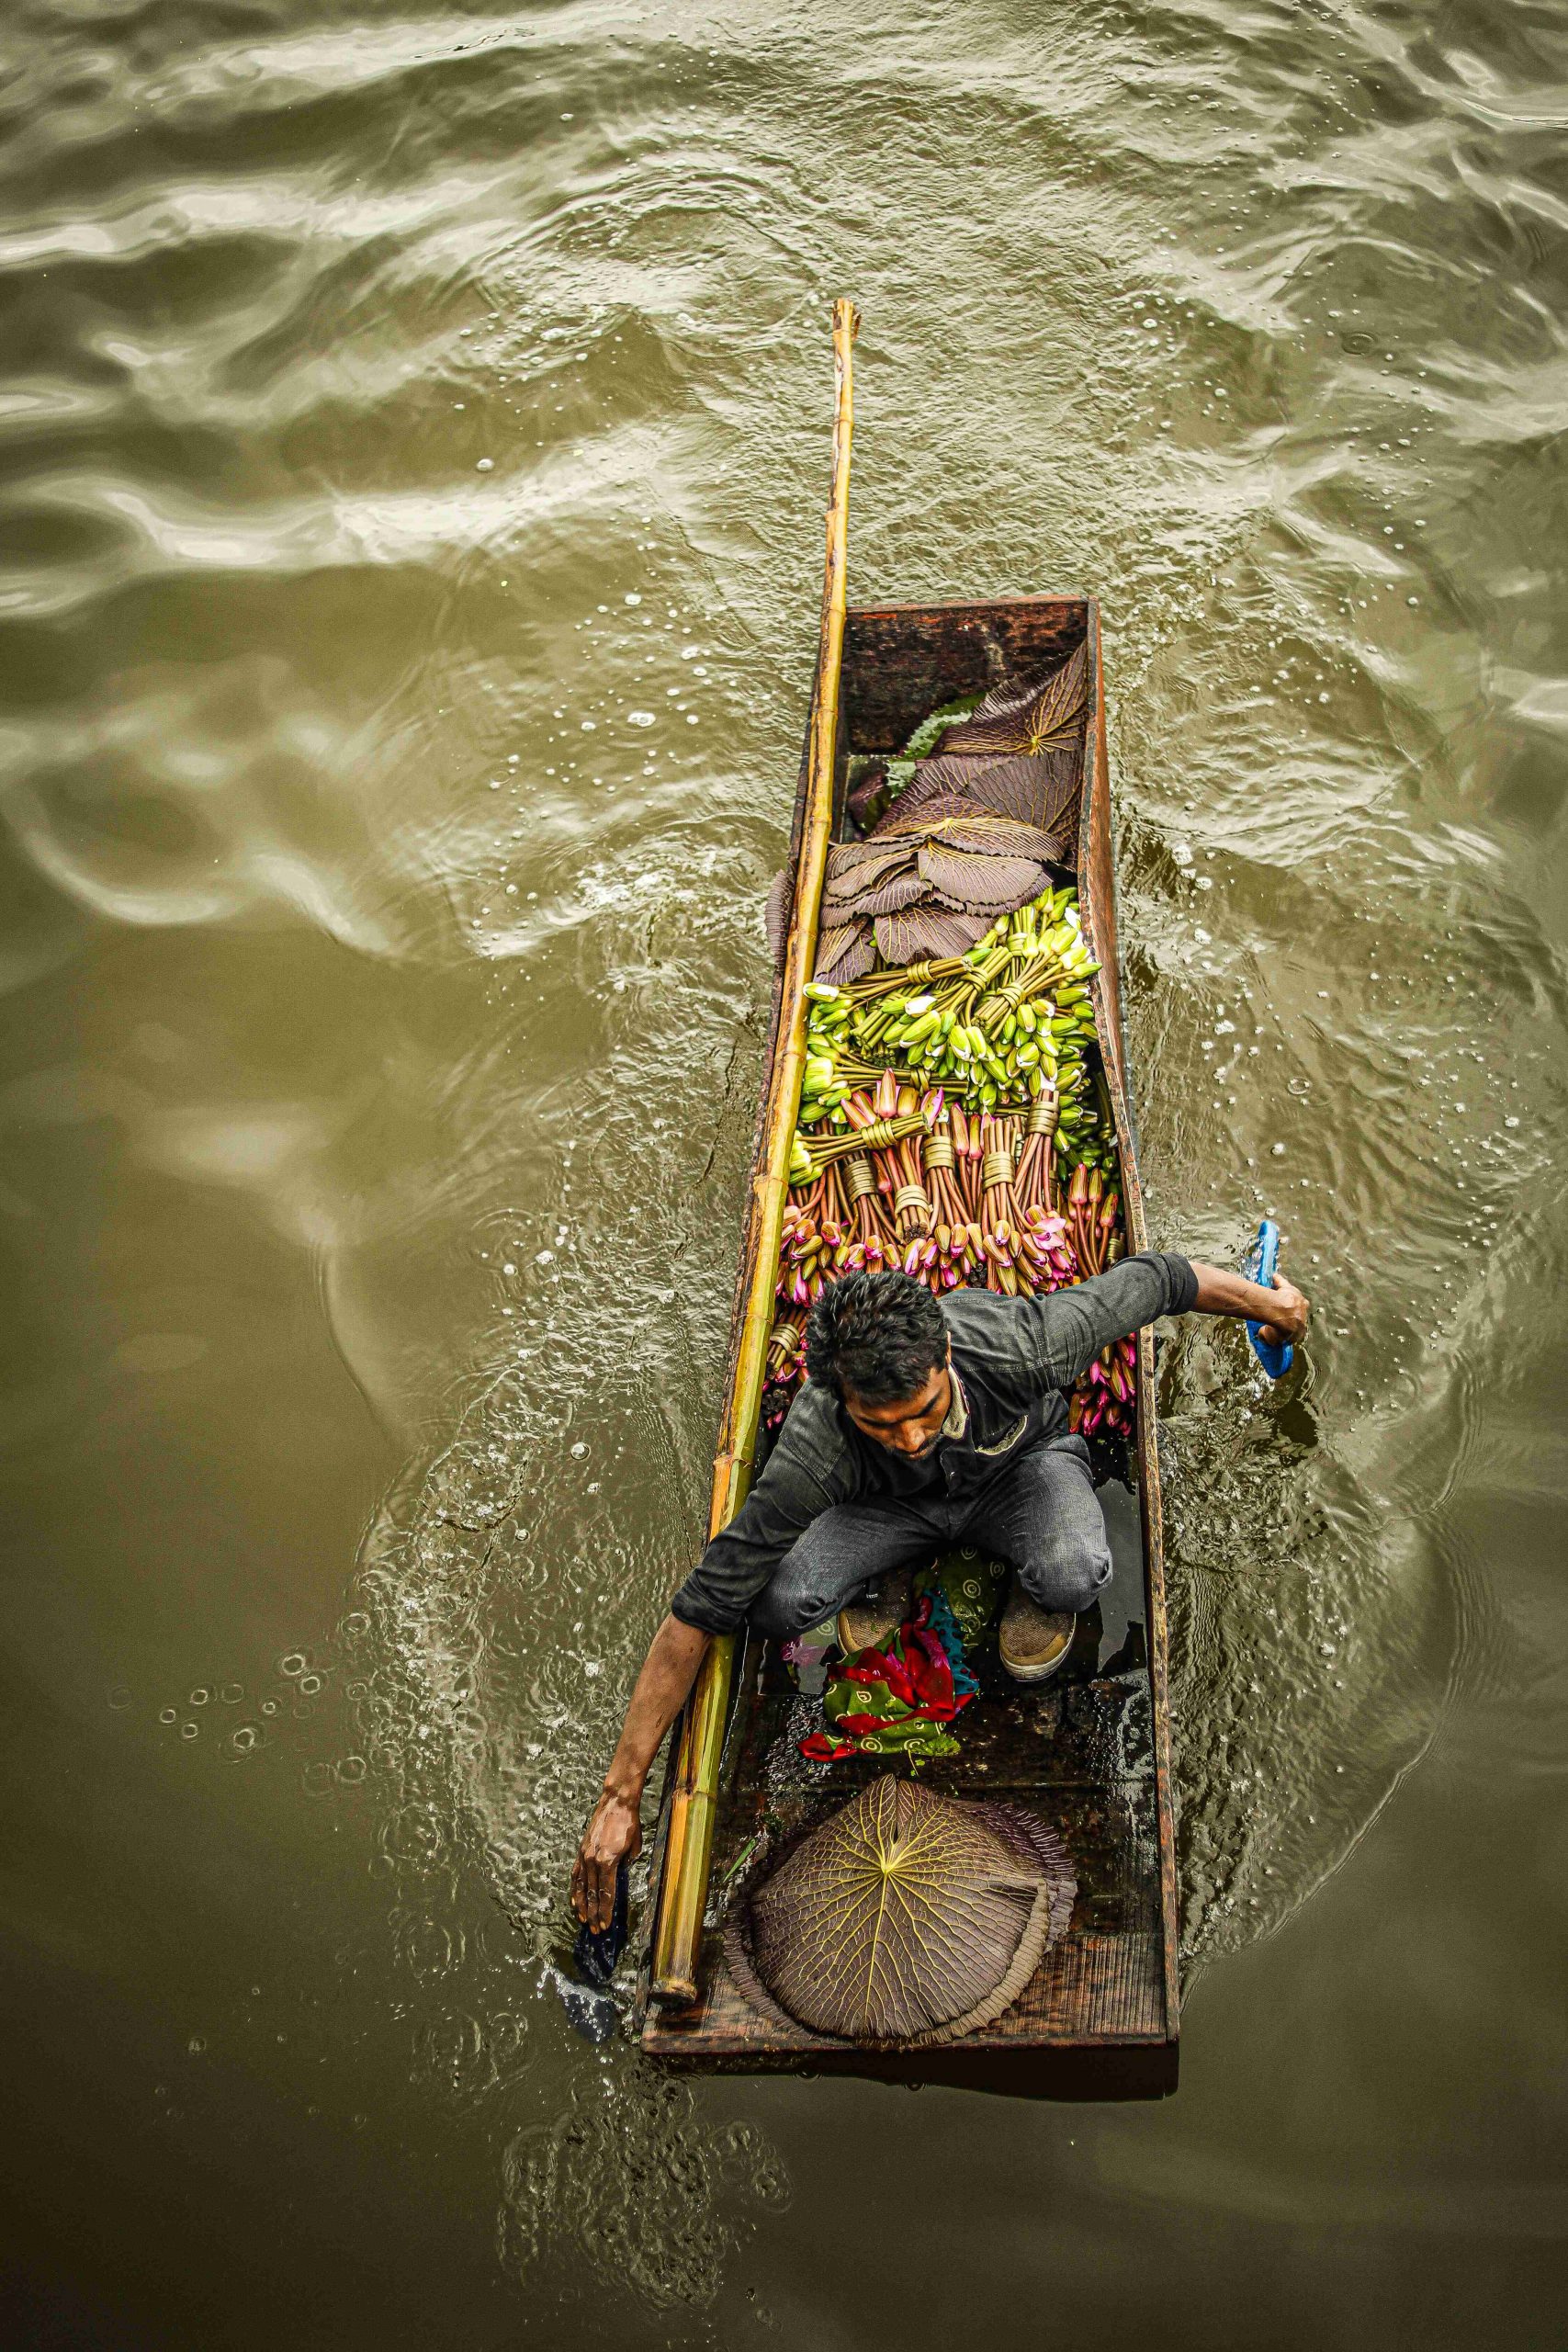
642 595 1178 2098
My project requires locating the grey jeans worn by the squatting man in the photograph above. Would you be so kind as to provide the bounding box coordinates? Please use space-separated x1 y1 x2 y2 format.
750 1437 1110 1642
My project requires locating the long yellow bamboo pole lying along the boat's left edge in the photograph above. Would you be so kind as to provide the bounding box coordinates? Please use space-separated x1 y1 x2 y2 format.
649 301 861 2004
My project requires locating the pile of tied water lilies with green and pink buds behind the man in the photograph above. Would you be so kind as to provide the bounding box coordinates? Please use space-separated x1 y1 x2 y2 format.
764 889 1134 1435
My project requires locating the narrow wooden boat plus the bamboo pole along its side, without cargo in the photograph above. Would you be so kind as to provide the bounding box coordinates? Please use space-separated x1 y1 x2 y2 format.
639 306 1178 2098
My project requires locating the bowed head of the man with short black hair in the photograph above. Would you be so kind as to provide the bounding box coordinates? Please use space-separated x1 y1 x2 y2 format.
807 1272 952 1456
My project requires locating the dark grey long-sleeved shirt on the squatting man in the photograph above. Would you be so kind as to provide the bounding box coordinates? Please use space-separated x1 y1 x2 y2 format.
670 1249 1199 1633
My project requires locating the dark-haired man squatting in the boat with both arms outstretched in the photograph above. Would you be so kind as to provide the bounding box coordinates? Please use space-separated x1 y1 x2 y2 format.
571 1251 1307 1928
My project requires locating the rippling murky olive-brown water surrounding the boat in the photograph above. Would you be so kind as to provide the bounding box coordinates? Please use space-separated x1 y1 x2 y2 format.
0 0 1568 2352
